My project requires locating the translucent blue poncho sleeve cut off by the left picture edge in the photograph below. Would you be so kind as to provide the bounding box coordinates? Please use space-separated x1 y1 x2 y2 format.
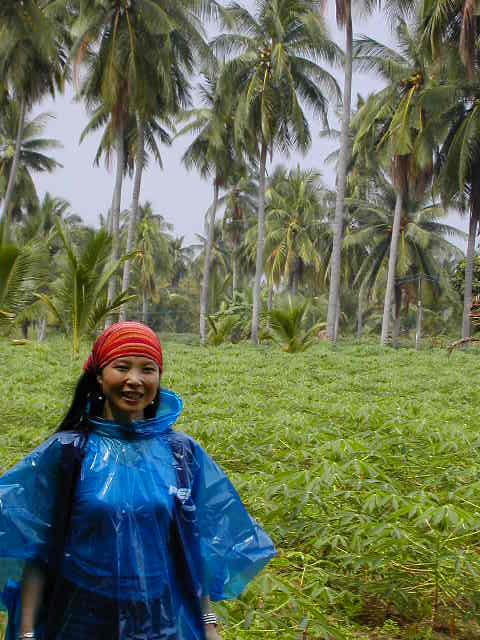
0 434 72 607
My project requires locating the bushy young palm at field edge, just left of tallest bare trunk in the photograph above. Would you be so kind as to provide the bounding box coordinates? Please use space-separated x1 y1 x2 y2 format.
268 298 325 353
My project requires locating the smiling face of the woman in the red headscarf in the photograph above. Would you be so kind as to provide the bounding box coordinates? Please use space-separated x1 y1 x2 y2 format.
97 356 160 423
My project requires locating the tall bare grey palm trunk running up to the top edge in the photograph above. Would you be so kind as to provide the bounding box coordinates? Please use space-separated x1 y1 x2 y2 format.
327 2 353 342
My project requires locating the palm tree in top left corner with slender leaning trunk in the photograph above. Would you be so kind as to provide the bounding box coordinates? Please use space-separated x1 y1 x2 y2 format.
0 0 68 233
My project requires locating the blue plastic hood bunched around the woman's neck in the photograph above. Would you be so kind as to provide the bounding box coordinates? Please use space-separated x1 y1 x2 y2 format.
86 389 183 440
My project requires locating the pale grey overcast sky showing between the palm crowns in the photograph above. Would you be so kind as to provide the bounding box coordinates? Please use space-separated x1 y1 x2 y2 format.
31 5 465 250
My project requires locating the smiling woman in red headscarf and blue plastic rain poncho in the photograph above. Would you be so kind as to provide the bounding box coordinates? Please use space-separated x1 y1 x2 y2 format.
0 322 275 640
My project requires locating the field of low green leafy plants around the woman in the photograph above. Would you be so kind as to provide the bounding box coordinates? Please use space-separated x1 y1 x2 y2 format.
0 340 480 640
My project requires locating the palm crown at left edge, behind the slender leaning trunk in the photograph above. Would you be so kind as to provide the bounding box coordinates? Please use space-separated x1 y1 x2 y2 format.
0 97 61 225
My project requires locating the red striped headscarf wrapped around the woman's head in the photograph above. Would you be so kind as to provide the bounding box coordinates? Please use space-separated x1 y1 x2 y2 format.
83 322 163 374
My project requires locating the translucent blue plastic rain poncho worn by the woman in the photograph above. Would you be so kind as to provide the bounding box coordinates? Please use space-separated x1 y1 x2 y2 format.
0 391 275 640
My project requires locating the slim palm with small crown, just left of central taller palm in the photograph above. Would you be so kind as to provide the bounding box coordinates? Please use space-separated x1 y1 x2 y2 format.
179 67 238 344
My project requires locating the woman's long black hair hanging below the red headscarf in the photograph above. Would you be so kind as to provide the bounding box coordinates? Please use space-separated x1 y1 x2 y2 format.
57 372 160 433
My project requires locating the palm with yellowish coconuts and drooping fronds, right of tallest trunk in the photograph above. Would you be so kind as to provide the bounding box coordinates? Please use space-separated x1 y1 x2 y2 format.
353 19 435 345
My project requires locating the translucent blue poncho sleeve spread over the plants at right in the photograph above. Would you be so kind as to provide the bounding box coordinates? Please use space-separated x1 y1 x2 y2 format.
192 443 276 600
